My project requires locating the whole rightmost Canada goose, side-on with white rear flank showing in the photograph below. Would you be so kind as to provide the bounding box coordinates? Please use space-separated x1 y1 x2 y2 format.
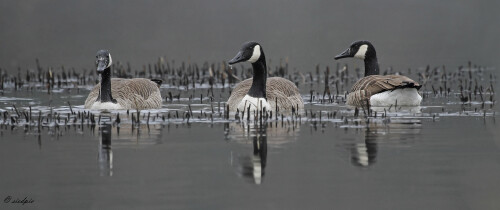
335 41 422 106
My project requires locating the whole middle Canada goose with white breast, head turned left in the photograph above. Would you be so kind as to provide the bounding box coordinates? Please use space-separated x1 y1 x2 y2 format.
227 42 304 113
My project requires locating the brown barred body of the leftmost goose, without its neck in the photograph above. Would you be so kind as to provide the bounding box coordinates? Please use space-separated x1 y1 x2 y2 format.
85 78 162 109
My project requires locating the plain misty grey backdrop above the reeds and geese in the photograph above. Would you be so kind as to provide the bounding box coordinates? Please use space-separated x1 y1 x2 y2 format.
0 0 500 71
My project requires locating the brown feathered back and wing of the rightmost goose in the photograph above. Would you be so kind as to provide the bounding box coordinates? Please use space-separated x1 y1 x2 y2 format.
346 75 421 106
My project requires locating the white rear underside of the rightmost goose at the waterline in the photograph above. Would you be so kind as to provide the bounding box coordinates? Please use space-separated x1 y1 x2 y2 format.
370 88 422 106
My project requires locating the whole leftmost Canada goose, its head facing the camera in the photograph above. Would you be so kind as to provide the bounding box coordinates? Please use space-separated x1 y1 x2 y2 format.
85 50 161 110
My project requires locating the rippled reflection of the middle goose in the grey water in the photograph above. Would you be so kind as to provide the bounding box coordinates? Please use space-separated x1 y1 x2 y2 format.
224 123 299 185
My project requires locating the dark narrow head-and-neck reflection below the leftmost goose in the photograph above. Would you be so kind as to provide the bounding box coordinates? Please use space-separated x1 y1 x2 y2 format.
98 124 113 176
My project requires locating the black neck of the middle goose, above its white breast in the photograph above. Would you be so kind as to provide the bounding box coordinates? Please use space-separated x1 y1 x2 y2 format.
248 52 267 100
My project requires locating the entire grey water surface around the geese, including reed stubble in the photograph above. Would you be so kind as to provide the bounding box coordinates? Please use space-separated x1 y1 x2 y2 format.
0 65 500 209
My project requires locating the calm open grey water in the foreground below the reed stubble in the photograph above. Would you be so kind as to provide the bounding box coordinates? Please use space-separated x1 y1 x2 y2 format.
0 117 500 209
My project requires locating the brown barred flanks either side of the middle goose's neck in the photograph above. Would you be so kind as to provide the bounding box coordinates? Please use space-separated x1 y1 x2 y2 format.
227 77 304 112
